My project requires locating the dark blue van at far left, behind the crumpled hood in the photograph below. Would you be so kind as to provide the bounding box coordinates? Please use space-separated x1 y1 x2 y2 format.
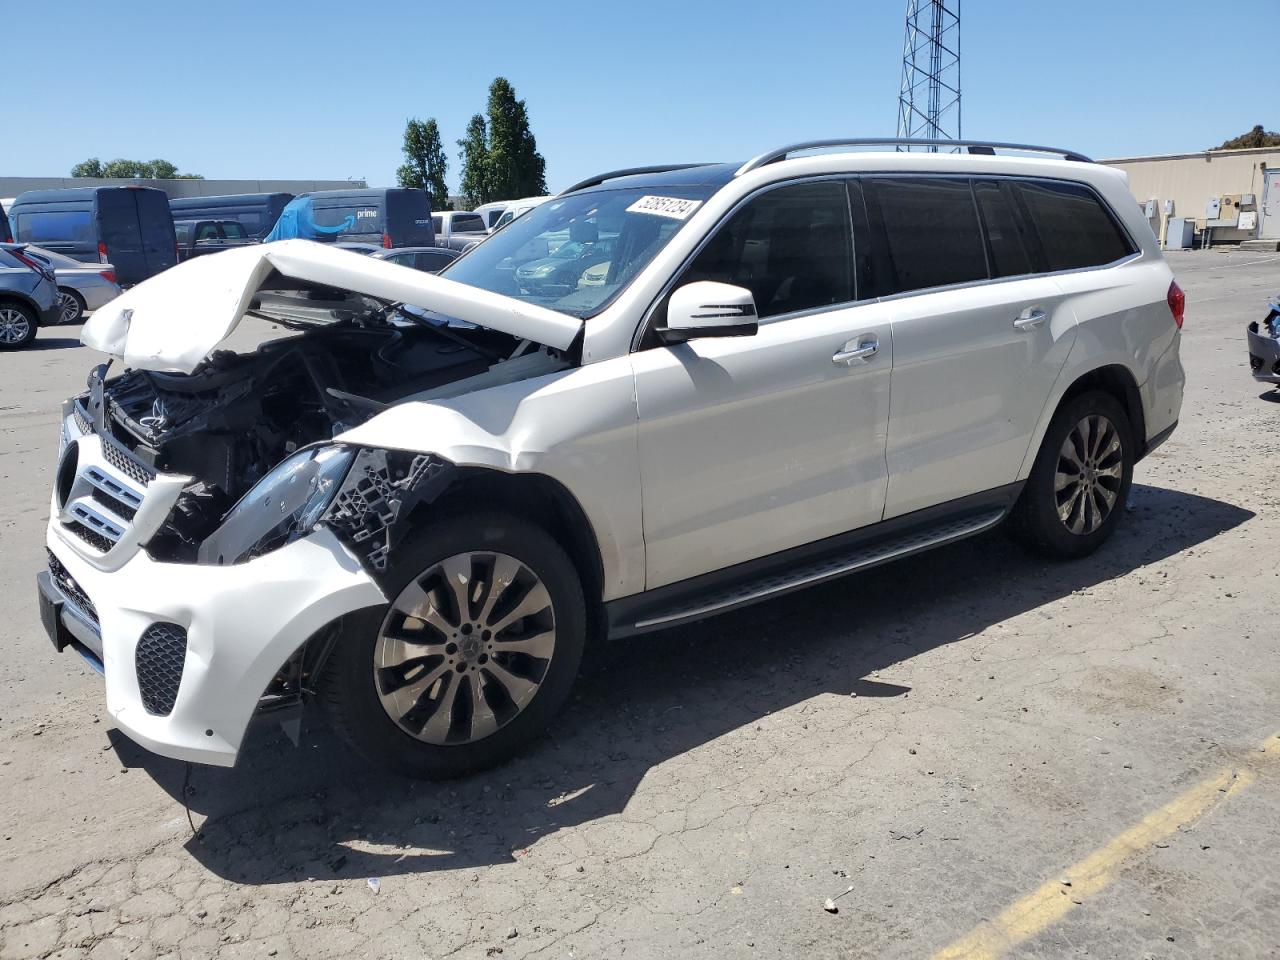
9 187 178 287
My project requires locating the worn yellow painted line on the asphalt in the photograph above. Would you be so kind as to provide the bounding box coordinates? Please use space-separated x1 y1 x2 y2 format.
933 733 1280 960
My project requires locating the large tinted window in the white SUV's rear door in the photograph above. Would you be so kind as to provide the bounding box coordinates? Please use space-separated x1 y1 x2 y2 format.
864 177 987 292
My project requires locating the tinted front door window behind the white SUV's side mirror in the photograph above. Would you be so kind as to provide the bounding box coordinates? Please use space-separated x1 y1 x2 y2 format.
677 180 854 317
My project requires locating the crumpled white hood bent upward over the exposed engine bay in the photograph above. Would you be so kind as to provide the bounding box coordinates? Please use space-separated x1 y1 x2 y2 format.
81 239 582 374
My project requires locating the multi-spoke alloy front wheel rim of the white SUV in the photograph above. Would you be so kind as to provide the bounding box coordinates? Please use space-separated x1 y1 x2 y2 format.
372 552 556 745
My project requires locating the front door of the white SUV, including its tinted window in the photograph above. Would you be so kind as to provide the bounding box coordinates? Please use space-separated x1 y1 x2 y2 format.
632 180 892 590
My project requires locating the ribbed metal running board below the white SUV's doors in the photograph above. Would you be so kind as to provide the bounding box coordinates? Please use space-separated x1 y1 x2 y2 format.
611 507 1007 636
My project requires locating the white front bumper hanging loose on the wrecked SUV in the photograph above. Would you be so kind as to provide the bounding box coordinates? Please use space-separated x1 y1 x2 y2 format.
40 517 385 767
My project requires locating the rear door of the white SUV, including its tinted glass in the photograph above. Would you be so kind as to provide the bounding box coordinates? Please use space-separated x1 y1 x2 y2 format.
863 175 1076 518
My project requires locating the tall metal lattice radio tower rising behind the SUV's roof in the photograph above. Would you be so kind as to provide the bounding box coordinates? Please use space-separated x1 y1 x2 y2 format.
897 0 960 151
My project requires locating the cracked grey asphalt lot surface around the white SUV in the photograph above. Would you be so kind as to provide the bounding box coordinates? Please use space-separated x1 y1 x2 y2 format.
0 251 1280 960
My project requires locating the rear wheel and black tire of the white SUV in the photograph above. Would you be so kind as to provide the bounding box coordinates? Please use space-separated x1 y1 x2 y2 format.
1007 390 1137 559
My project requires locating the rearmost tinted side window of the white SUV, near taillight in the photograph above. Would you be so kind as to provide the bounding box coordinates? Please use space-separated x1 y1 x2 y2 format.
1011 180 1134 270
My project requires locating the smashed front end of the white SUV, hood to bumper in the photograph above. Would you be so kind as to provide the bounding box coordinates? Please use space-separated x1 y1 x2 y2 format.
41 244 576 764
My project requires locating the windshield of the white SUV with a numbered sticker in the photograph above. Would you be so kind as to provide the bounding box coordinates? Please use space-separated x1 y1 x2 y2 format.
442 186 716 319
